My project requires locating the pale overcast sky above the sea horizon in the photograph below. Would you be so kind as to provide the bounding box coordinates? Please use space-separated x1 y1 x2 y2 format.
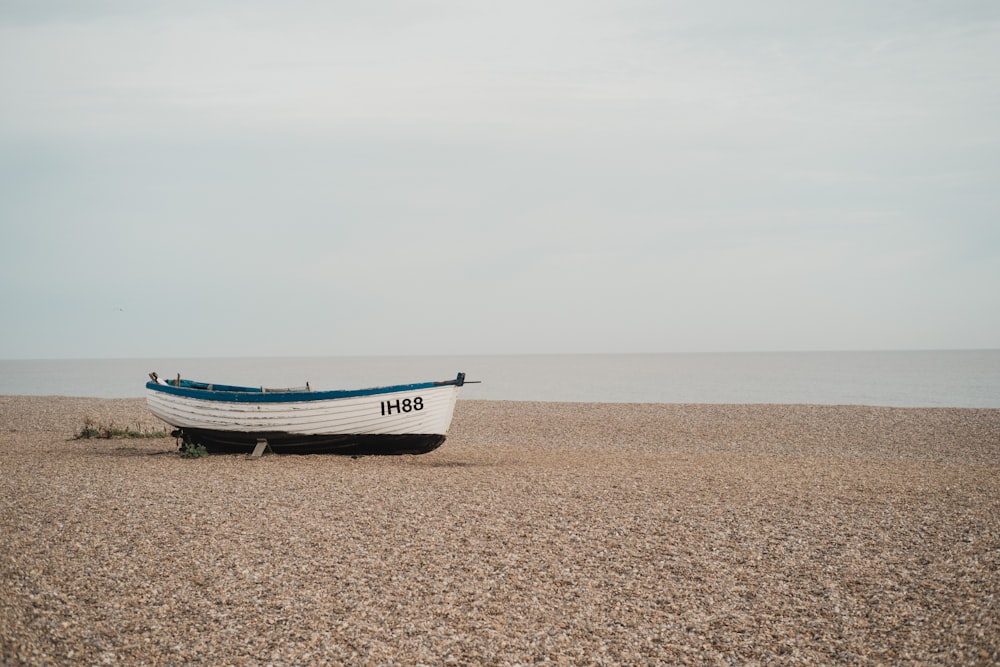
0 0 1000 358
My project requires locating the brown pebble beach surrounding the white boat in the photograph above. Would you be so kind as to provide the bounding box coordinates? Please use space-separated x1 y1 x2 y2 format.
0 396 1000 665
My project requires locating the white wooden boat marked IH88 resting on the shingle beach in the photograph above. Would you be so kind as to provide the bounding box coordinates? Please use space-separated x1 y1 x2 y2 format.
146 373 466 454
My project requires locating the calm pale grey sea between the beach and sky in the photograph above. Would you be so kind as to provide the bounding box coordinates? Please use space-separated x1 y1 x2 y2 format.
0 350 1000 408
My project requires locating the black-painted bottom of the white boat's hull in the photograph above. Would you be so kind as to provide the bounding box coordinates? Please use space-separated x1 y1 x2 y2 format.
174 429 445 456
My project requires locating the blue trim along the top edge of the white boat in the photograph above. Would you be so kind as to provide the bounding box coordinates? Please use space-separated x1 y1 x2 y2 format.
146 373 465 403
